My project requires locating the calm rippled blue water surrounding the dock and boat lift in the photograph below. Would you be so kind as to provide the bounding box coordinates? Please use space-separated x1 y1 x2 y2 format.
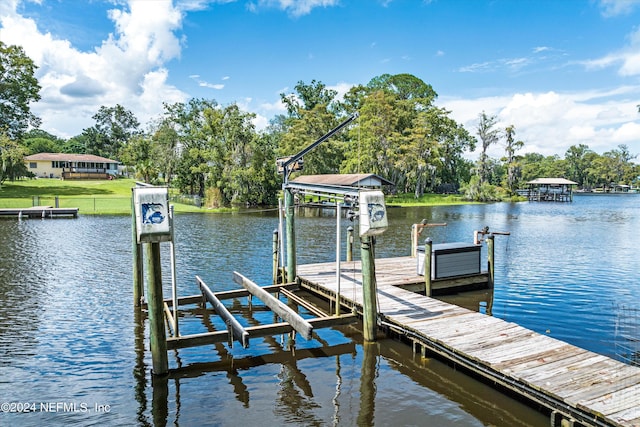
0 195 640 426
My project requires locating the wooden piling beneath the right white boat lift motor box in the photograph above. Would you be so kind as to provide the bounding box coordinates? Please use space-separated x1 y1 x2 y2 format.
360 236 378 342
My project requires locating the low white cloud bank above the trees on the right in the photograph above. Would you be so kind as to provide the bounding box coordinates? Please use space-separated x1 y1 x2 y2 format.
437 87 640 160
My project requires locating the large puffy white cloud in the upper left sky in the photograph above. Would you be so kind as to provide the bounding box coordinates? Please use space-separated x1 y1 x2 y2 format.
0 0 190 137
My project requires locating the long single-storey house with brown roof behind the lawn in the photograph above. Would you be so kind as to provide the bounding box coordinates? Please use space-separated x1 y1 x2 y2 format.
24 153 119 179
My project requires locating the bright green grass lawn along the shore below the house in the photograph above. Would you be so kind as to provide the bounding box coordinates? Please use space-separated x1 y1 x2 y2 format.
0 178 207 215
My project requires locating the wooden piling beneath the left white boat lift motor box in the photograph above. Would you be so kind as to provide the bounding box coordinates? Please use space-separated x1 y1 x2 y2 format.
144 243 169 375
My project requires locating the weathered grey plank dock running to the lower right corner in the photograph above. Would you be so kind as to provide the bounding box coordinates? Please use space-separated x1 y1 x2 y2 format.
297 257 640 427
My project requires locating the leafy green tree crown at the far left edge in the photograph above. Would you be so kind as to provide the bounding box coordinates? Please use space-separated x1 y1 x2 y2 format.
0 41 40 140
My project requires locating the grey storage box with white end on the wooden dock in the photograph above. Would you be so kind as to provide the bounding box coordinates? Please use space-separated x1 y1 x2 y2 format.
417 242 482 279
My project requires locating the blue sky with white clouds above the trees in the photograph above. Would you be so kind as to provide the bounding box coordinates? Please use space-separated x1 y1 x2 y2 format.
0 0 640 161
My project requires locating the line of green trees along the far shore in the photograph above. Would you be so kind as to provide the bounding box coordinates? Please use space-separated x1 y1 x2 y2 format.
0 42 639 206
